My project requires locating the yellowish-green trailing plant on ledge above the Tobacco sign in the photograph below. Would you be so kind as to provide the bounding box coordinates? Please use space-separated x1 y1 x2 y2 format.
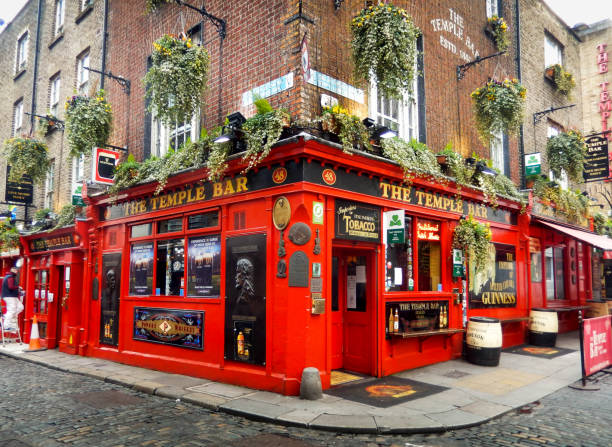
320 105 372 153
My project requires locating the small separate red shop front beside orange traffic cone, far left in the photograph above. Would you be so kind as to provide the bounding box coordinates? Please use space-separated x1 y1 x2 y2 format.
21 220 87 354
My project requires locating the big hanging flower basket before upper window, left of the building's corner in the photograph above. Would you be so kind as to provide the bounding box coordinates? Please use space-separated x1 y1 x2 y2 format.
144 34 209 124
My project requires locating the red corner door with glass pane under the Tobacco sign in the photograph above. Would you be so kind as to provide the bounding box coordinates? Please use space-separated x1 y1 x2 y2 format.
331 249 376 375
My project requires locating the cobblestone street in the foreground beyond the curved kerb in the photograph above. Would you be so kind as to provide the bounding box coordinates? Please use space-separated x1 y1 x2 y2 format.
0 356 612 447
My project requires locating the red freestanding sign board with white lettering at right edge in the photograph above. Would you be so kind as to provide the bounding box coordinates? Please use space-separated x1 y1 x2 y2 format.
582 315 612 376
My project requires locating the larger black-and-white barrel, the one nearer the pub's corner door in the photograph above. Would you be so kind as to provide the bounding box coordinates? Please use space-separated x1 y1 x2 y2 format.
465 317 502 366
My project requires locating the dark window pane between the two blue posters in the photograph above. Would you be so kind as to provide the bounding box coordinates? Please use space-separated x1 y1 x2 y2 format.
155 239 185 296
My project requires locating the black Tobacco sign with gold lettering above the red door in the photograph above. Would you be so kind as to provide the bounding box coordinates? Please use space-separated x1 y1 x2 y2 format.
335 199 380 242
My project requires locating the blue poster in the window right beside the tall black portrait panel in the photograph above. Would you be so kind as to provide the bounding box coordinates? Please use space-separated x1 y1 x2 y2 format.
187 234 221 297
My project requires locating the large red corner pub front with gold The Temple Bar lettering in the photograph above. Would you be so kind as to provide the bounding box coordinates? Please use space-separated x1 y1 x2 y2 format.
83 138 528 394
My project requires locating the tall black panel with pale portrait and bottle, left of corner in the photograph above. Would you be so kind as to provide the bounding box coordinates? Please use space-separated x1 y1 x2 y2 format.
225 234 266 365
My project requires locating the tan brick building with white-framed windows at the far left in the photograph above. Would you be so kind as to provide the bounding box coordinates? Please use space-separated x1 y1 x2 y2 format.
0 0 104 224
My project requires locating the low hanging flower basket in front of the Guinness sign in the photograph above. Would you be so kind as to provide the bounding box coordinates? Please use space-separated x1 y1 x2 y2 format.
453 215 491 270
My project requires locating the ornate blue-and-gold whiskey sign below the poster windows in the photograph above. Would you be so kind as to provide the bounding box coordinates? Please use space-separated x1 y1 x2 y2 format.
133 307 204 350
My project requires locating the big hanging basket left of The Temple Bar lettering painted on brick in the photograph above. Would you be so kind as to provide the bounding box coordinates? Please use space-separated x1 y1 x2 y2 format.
351 3 420 99
